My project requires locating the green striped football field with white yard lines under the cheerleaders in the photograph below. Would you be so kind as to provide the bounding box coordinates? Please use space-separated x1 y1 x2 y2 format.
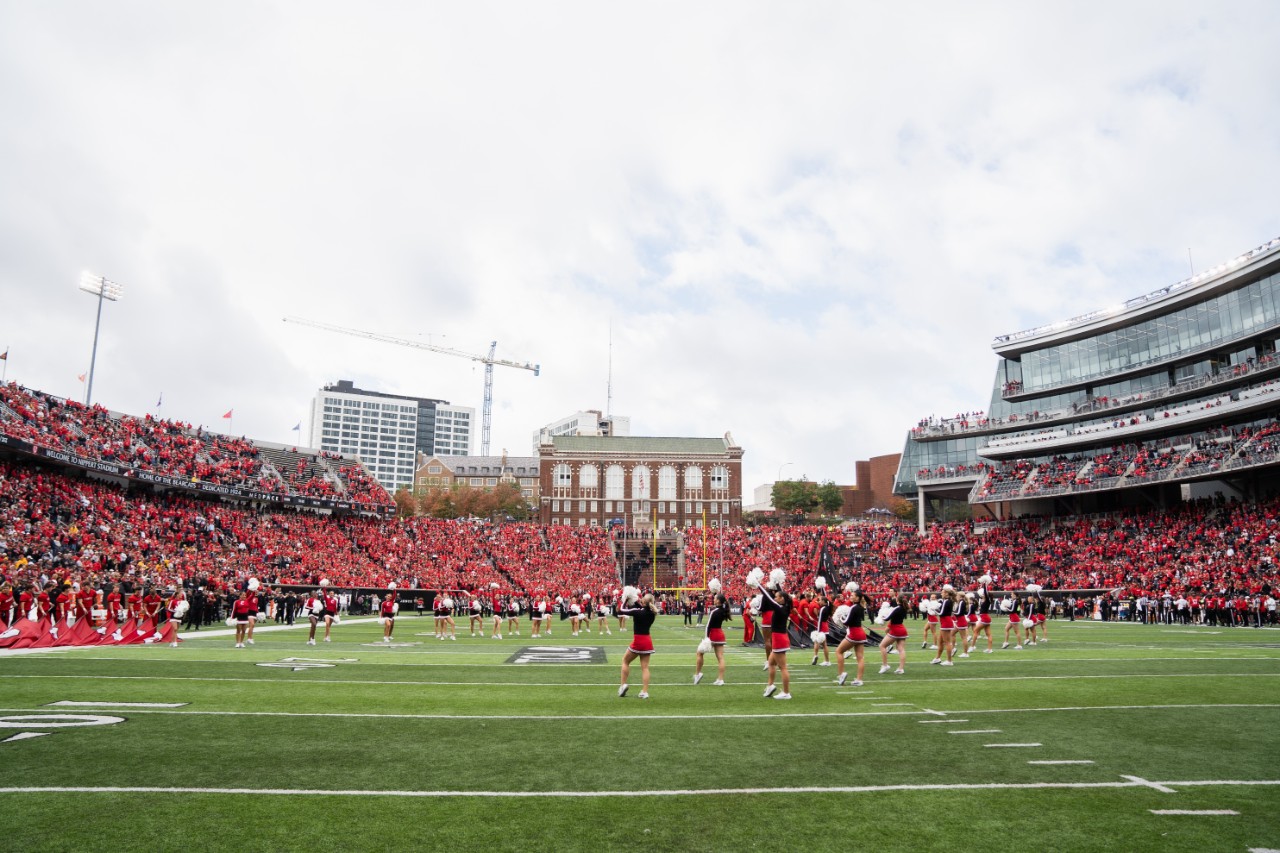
0 615 1280 853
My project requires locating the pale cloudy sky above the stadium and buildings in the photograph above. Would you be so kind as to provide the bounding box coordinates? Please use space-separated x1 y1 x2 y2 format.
0 0 1280 502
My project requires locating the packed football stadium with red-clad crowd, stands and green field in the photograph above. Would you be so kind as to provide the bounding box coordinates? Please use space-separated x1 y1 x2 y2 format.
0 234 1280 850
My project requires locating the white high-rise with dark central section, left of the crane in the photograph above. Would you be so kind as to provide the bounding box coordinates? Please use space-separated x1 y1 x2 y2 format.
311 379 476 493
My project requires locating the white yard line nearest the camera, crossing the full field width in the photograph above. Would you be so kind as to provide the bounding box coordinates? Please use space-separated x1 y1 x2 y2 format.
0 779 1280 799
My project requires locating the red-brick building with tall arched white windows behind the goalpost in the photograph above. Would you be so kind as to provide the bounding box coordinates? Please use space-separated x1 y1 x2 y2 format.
538 433 742 530
